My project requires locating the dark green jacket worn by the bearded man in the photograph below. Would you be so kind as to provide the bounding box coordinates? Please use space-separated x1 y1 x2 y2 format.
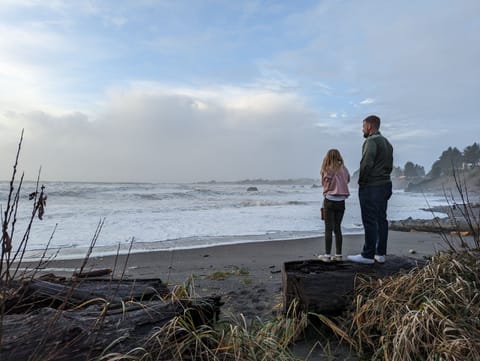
358 132 393 187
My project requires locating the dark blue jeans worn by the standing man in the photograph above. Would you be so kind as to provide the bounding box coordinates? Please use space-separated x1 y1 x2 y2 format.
358 183 392 258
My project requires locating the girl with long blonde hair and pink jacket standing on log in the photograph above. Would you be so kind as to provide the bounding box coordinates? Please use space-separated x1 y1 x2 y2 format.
318 149 350 262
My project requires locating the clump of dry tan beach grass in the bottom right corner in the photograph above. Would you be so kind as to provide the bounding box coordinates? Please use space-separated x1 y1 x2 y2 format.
347 250 480 361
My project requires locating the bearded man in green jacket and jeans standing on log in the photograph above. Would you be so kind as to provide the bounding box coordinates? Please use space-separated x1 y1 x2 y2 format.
348 115 393 264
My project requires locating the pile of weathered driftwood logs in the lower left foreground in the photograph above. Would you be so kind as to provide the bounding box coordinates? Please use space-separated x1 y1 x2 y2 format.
0 279 221 361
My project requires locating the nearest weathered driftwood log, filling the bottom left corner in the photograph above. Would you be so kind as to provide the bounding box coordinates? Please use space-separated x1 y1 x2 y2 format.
0 299 218 361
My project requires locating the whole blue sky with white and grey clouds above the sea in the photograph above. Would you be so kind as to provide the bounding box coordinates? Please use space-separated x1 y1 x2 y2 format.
0 0 480 182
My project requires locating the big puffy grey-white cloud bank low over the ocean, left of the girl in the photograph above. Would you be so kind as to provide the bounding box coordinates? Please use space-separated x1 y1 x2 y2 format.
0 84 352 181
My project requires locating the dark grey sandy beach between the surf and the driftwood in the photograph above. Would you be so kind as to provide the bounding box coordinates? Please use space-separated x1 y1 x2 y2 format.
37 231 445 319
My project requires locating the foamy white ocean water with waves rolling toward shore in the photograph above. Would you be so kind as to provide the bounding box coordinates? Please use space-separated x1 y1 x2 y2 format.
0 182 446 259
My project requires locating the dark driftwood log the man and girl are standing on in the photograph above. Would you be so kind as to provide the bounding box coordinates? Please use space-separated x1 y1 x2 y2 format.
282 256 424 315
